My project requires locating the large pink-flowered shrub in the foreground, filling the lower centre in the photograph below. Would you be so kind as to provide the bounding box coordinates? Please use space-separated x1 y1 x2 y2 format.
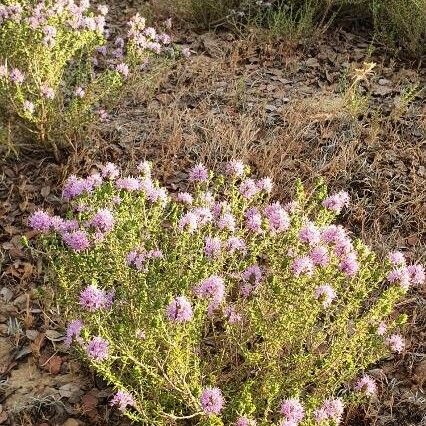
29 161 425 426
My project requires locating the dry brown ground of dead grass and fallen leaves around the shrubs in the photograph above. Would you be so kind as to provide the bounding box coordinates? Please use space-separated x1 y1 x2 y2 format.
0 19 426 426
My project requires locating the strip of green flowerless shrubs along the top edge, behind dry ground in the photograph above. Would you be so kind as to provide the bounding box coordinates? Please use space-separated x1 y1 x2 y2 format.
155 0 426 56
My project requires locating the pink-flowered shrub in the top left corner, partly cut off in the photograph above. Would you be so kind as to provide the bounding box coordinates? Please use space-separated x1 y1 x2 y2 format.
0 0 171 149
